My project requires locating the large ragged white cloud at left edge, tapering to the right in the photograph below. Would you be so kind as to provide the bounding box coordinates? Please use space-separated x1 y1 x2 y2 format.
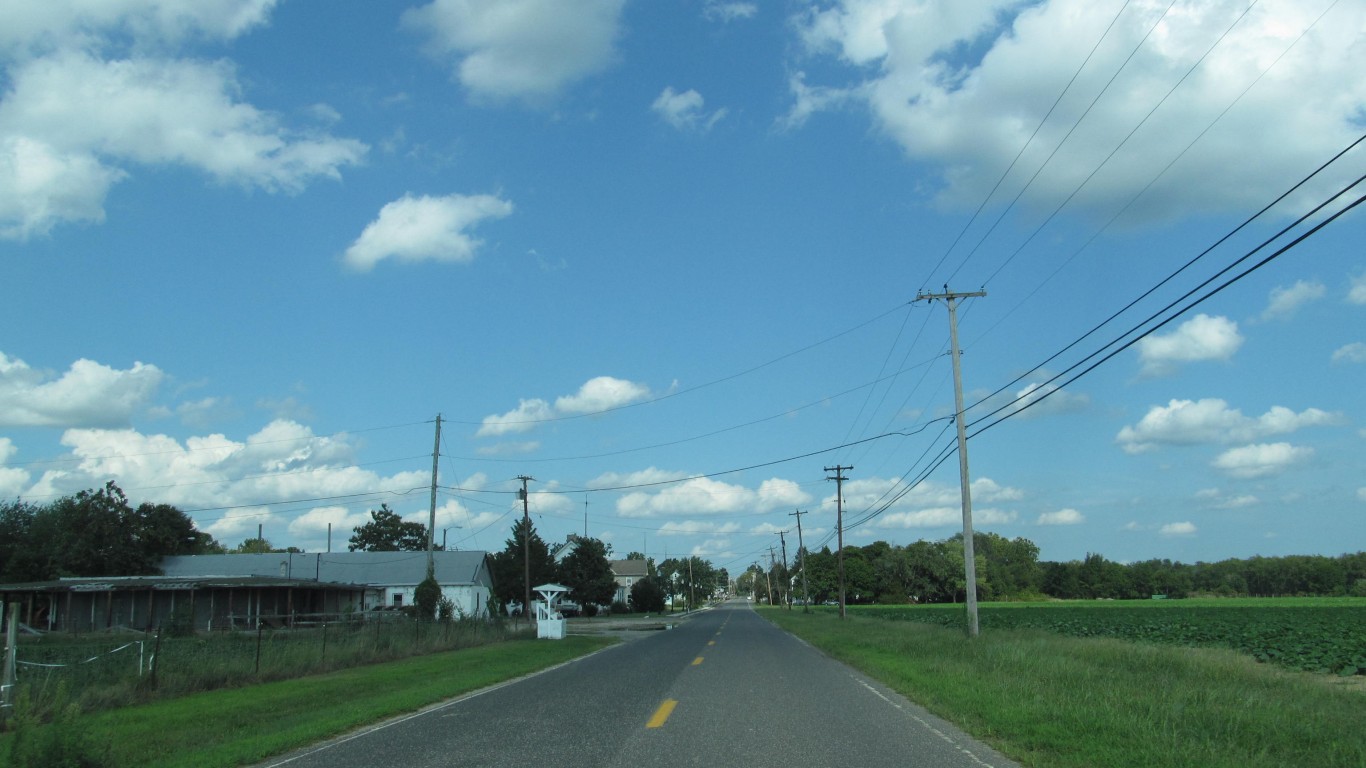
0 51 366 238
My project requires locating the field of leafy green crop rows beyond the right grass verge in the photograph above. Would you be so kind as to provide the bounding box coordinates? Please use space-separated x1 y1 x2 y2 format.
850 597 1366 676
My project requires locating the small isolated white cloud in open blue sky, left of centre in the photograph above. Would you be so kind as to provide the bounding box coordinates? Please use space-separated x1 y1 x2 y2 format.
344 194 512 272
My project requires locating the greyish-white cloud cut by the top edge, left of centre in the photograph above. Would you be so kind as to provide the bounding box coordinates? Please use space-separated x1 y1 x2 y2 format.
403 0 626 101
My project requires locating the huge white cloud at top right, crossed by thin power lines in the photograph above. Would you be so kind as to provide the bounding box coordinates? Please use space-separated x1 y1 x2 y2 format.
790 0 1366 216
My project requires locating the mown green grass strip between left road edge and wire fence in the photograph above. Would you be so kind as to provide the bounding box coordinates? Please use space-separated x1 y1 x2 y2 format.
0 637 613 768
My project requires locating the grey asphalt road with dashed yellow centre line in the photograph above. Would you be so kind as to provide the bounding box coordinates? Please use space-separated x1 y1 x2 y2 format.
266 601 1016 768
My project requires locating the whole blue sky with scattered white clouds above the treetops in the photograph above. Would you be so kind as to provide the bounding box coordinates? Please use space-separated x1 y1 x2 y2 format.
0 0 1366 570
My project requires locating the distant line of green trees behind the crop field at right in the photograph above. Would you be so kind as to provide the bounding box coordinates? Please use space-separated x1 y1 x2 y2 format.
738 532 1366 604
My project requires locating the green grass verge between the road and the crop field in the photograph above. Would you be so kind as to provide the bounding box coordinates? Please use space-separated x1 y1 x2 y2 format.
761 608 1366 768
